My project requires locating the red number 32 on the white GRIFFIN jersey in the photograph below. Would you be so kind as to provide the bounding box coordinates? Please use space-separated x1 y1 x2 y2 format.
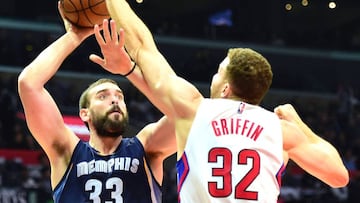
208 148 260 200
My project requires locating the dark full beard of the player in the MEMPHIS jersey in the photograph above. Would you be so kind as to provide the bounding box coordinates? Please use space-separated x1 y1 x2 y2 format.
92 106 129 137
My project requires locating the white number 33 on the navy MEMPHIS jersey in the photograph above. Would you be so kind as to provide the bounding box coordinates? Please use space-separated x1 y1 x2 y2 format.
85 177 123 203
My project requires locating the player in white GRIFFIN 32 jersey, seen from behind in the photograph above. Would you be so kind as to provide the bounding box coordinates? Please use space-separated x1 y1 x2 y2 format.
90 0 349 203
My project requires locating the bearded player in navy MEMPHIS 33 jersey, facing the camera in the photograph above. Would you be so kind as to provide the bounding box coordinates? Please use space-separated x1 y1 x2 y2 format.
18 2 176 203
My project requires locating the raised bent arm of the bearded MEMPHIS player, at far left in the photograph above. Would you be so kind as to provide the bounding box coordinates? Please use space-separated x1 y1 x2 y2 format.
18 0 92 189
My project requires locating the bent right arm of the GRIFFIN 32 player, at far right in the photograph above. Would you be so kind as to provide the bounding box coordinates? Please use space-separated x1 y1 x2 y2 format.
275 104 349 187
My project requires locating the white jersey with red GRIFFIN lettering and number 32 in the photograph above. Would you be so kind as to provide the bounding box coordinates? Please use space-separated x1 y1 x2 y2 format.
177 99 284 203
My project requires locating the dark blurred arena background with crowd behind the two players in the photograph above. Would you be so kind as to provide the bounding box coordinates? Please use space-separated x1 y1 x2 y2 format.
0 0 360 203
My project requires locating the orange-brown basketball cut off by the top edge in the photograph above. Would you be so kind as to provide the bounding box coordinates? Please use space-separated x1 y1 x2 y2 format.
60 0 110 27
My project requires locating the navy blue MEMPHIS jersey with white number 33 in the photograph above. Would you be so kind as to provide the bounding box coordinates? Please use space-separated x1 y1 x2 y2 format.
53 137 161 203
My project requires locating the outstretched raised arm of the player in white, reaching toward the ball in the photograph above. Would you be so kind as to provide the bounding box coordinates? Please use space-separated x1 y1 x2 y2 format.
102 0 202 117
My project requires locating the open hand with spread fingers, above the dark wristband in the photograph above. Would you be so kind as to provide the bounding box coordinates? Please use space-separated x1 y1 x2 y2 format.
89 19 133 75
